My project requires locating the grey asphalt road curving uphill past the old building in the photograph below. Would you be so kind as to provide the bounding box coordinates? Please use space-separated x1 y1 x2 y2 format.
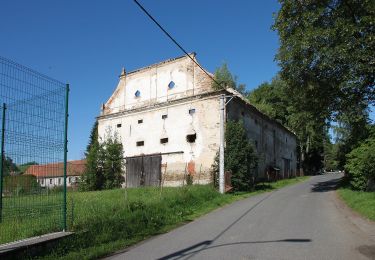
106 174 375 260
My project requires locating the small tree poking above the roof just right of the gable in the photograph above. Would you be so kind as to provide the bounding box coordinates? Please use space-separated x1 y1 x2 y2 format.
212 63 246 95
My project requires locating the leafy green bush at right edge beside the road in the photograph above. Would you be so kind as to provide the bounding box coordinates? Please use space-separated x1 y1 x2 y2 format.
345 135 375 190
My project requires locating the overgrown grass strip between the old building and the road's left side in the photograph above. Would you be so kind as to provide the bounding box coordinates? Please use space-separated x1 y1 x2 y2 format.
2 177 307 259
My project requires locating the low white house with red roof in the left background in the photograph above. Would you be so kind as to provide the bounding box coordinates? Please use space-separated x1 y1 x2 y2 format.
25 160 86 188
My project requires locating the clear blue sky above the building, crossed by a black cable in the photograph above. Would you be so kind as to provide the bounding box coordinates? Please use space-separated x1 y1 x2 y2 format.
0 0 374 160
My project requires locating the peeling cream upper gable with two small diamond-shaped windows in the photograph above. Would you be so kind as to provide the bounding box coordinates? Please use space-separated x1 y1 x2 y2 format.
102 56 211 115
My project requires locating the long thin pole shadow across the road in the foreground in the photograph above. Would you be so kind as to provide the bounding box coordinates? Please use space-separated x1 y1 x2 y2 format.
157 238 312 260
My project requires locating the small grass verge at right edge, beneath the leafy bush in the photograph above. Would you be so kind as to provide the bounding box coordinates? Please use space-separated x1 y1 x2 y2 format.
337 188 375 221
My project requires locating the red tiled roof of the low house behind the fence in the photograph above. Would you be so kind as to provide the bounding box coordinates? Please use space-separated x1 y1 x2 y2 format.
25 160 86 177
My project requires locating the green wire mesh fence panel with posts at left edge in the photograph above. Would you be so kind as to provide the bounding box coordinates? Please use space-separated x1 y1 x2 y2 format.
0 57 68 244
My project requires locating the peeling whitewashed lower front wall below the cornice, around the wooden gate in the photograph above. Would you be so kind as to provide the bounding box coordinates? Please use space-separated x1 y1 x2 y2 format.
98 96 220 186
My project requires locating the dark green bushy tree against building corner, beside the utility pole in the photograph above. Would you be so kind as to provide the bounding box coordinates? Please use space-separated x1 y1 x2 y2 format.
212 121 258 191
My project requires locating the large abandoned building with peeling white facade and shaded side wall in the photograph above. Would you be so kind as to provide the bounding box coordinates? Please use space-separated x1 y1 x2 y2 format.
98 53 297 187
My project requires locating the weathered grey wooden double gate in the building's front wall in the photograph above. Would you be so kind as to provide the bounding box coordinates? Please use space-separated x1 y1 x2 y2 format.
126 155 161 187
